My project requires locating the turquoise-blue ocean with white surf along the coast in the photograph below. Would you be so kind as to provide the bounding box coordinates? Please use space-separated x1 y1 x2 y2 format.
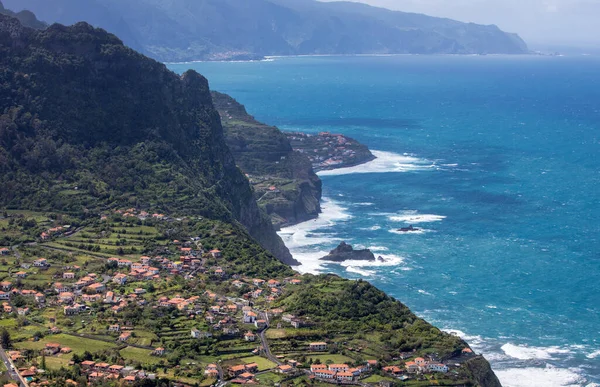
169 56 600 387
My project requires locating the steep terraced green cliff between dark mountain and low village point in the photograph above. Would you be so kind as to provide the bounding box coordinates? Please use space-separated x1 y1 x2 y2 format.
212 92 321 227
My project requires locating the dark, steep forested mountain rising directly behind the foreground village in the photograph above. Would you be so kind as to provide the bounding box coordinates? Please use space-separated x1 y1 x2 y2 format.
0 15 295 264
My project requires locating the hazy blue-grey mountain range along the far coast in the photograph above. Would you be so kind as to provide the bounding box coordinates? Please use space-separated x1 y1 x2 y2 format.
4 0 528 61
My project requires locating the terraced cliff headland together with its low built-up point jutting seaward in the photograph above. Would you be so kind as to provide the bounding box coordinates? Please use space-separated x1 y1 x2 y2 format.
211 91 375 228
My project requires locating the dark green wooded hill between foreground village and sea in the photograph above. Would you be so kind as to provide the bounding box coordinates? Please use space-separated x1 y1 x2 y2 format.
282 275 464 356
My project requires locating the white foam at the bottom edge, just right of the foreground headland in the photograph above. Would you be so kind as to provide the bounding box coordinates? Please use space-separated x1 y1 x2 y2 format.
495 365 584 387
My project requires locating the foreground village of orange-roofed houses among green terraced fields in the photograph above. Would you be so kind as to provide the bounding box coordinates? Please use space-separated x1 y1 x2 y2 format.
0 208 476 387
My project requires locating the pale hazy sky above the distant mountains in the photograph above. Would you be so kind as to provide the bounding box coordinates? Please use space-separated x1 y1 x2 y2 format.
321 0 600 49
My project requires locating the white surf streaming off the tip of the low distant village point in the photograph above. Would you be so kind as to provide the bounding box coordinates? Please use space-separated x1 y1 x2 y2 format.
317 151 435 176
